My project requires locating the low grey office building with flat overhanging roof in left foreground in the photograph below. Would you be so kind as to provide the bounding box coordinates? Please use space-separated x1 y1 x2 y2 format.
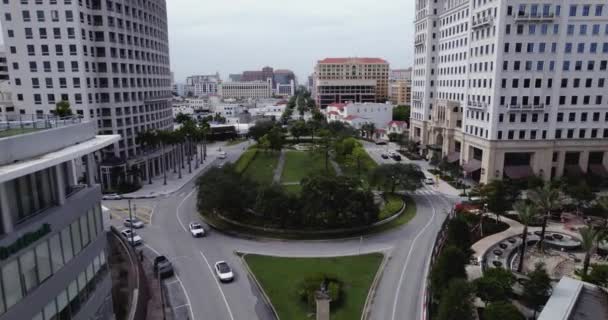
0 119 120 320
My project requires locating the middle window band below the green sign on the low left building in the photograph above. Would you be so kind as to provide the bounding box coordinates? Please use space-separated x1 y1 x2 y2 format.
0 203 103 314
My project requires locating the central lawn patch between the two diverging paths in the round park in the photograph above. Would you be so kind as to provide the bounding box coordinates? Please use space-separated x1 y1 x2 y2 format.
281 151 334 182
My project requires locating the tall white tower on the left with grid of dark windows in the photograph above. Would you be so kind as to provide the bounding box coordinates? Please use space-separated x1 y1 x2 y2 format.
0 0 172 180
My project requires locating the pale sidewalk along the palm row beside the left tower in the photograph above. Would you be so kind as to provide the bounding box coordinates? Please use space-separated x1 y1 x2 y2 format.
122 142 232 199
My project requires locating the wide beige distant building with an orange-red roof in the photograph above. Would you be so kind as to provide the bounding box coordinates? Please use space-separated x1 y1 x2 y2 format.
313 58 389 108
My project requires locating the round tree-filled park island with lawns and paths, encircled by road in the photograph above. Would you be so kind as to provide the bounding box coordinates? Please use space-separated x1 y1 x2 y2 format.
197 122 423 239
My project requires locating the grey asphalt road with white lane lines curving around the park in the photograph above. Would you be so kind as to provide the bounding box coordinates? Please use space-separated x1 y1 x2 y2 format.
105 144 457 320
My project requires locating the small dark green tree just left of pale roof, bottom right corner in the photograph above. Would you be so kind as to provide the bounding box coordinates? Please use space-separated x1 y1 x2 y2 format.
522 262 551 319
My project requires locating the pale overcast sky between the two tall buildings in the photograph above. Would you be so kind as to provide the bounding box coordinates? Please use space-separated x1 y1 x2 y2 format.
0 0 414 82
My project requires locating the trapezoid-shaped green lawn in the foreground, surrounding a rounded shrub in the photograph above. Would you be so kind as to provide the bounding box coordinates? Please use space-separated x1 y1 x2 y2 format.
245 253 382 320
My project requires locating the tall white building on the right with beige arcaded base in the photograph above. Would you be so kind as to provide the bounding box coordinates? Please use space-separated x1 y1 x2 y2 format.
410 0 608 183
